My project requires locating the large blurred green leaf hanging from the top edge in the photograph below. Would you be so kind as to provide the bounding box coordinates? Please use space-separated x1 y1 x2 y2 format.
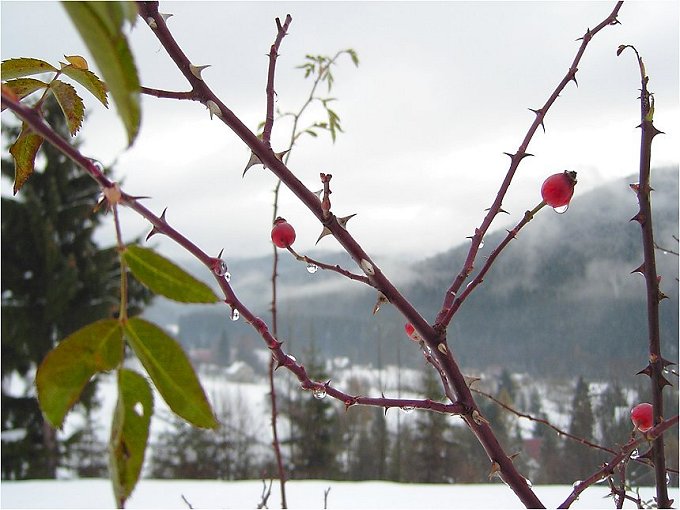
62 2 141 145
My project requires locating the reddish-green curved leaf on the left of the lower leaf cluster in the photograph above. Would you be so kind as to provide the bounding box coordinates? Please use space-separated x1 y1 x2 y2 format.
35 319 123 428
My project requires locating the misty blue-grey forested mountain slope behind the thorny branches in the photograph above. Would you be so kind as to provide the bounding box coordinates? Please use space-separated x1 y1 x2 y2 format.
147 167 678 377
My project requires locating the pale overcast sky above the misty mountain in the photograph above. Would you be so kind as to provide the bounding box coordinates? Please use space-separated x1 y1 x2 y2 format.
1 1 680 260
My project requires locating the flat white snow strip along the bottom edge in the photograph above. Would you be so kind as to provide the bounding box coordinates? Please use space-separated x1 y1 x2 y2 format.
0 480 678 510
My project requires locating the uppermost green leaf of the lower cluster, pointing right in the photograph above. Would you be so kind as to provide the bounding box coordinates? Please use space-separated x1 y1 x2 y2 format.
123 245 220 303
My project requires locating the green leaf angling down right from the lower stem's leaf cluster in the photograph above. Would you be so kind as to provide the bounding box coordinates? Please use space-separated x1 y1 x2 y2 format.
125 317 217 428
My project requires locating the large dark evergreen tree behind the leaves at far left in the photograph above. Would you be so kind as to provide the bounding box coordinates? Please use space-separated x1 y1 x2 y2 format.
2 100 148 479
